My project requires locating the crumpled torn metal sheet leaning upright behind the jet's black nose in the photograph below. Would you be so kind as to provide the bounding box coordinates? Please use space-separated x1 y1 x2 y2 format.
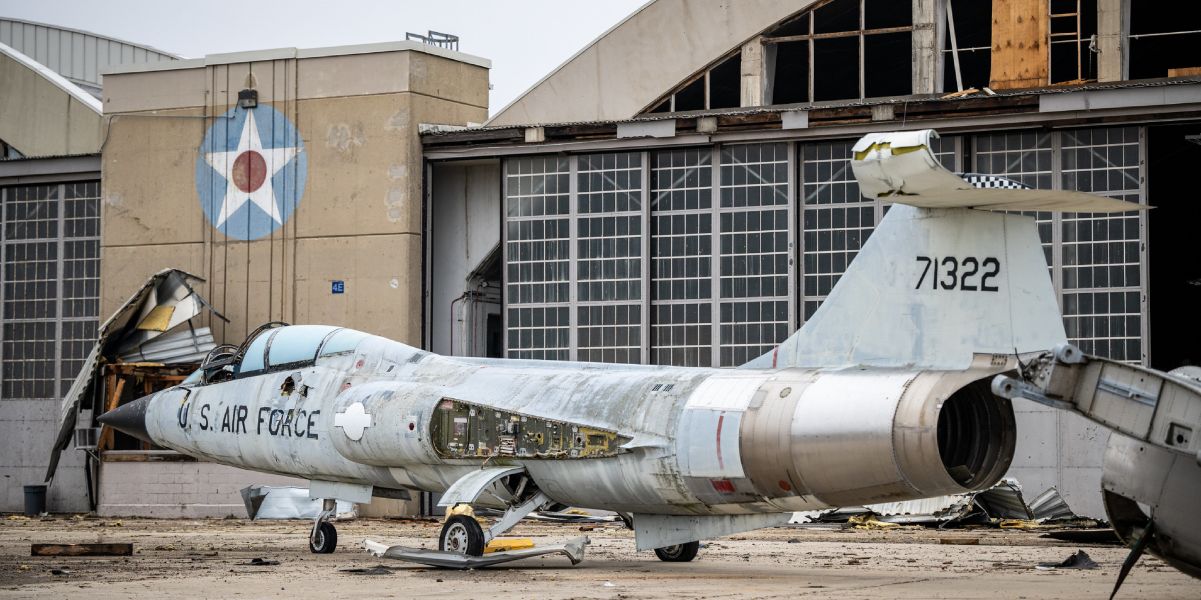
46 269 225 485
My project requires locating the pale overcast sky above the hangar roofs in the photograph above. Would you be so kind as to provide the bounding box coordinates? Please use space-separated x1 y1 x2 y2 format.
0 0 645 114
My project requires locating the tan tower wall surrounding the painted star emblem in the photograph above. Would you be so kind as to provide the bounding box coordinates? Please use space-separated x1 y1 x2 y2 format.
101 50 488 344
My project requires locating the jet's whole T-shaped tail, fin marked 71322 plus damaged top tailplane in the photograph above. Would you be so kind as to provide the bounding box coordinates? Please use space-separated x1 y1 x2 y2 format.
746 131 1139 368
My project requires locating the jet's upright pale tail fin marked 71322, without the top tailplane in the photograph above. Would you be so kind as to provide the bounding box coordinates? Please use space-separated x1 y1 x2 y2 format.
747 204 1065 368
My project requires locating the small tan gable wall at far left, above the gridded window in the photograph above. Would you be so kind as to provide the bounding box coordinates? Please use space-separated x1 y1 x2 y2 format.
0 48 101 156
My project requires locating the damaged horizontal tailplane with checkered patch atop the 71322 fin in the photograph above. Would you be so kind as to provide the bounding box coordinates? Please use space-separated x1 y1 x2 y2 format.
850 130 1147 212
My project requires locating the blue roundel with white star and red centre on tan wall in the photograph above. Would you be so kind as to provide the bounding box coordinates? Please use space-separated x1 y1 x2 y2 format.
196 104 309 240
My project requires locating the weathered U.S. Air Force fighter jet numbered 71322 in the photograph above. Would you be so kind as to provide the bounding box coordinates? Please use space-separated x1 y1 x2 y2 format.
101 130 1201 578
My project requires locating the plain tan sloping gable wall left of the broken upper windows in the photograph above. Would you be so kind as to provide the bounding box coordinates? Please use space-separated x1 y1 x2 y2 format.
489 0 814 125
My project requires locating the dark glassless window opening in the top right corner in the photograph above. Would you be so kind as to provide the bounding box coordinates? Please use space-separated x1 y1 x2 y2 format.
1129 1 1201 79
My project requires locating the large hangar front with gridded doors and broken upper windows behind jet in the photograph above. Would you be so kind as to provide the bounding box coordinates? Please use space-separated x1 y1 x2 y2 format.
423 0 1201 516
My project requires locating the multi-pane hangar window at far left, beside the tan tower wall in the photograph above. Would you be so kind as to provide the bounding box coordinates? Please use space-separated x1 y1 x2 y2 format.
0 181 100 400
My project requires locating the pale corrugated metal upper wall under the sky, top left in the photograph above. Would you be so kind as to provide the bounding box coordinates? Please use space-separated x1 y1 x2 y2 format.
0 19 179 89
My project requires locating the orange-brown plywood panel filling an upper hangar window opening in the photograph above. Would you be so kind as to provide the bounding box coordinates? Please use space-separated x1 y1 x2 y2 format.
988 0 1050 90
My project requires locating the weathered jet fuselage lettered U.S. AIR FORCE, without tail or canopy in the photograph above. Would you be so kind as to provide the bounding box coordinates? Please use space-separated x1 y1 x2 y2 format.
147 336 1011 515
